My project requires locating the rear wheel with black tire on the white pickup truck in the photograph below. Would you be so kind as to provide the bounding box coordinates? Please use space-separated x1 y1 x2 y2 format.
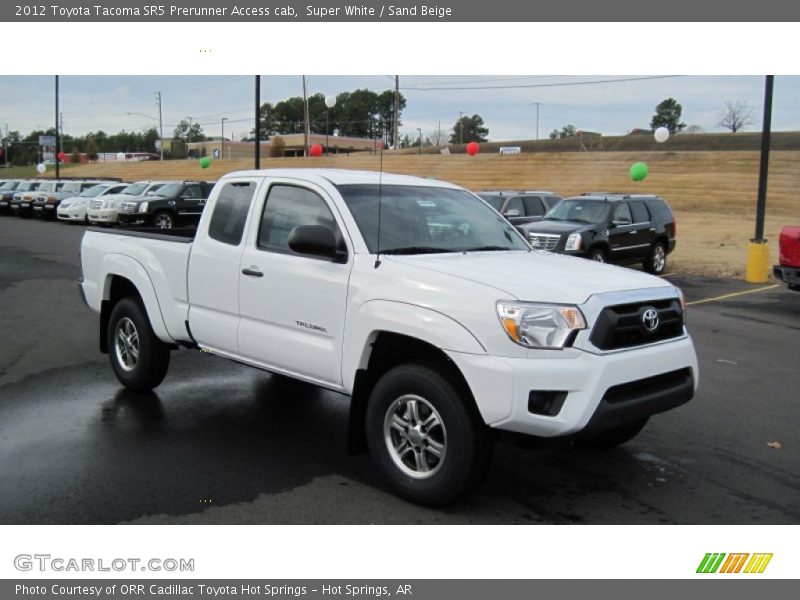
106 297 170 392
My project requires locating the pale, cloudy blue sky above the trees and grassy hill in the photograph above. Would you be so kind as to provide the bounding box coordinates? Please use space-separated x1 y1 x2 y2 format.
0 75 800 141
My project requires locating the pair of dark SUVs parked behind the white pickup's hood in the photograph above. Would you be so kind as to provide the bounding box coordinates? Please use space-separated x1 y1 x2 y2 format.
478 190 677 275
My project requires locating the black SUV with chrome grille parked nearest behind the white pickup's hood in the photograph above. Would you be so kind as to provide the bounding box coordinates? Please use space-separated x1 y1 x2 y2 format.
522 192 676 275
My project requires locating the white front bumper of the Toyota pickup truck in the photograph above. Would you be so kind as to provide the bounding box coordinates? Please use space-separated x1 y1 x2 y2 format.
448 335 698 437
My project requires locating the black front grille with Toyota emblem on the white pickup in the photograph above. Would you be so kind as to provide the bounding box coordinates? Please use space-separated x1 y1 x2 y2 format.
589 298 683 350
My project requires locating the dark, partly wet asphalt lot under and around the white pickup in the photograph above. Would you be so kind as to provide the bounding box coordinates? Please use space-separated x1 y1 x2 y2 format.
0 216 800 524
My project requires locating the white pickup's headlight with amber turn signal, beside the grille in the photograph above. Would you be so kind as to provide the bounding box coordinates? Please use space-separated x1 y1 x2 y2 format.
497 301 586 350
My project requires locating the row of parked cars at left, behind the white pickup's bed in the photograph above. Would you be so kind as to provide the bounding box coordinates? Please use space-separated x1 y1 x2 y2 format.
0 179 214 229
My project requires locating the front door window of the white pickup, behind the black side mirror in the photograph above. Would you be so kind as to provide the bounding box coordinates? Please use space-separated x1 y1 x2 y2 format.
258 184 338 254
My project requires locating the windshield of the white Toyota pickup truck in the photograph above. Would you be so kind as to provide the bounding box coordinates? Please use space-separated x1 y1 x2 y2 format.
338 184 530 254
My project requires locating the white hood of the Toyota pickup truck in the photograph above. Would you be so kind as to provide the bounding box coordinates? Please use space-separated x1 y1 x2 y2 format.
381 251 672 304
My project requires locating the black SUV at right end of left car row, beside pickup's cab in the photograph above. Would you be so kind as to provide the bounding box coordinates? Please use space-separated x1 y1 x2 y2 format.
117 181 214 229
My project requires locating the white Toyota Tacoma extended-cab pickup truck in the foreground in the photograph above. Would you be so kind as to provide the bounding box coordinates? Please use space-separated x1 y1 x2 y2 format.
80 169 698 505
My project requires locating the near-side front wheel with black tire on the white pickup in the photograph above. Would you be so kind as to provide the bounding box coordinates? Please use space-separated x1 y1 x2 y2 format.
366 363 493 506
